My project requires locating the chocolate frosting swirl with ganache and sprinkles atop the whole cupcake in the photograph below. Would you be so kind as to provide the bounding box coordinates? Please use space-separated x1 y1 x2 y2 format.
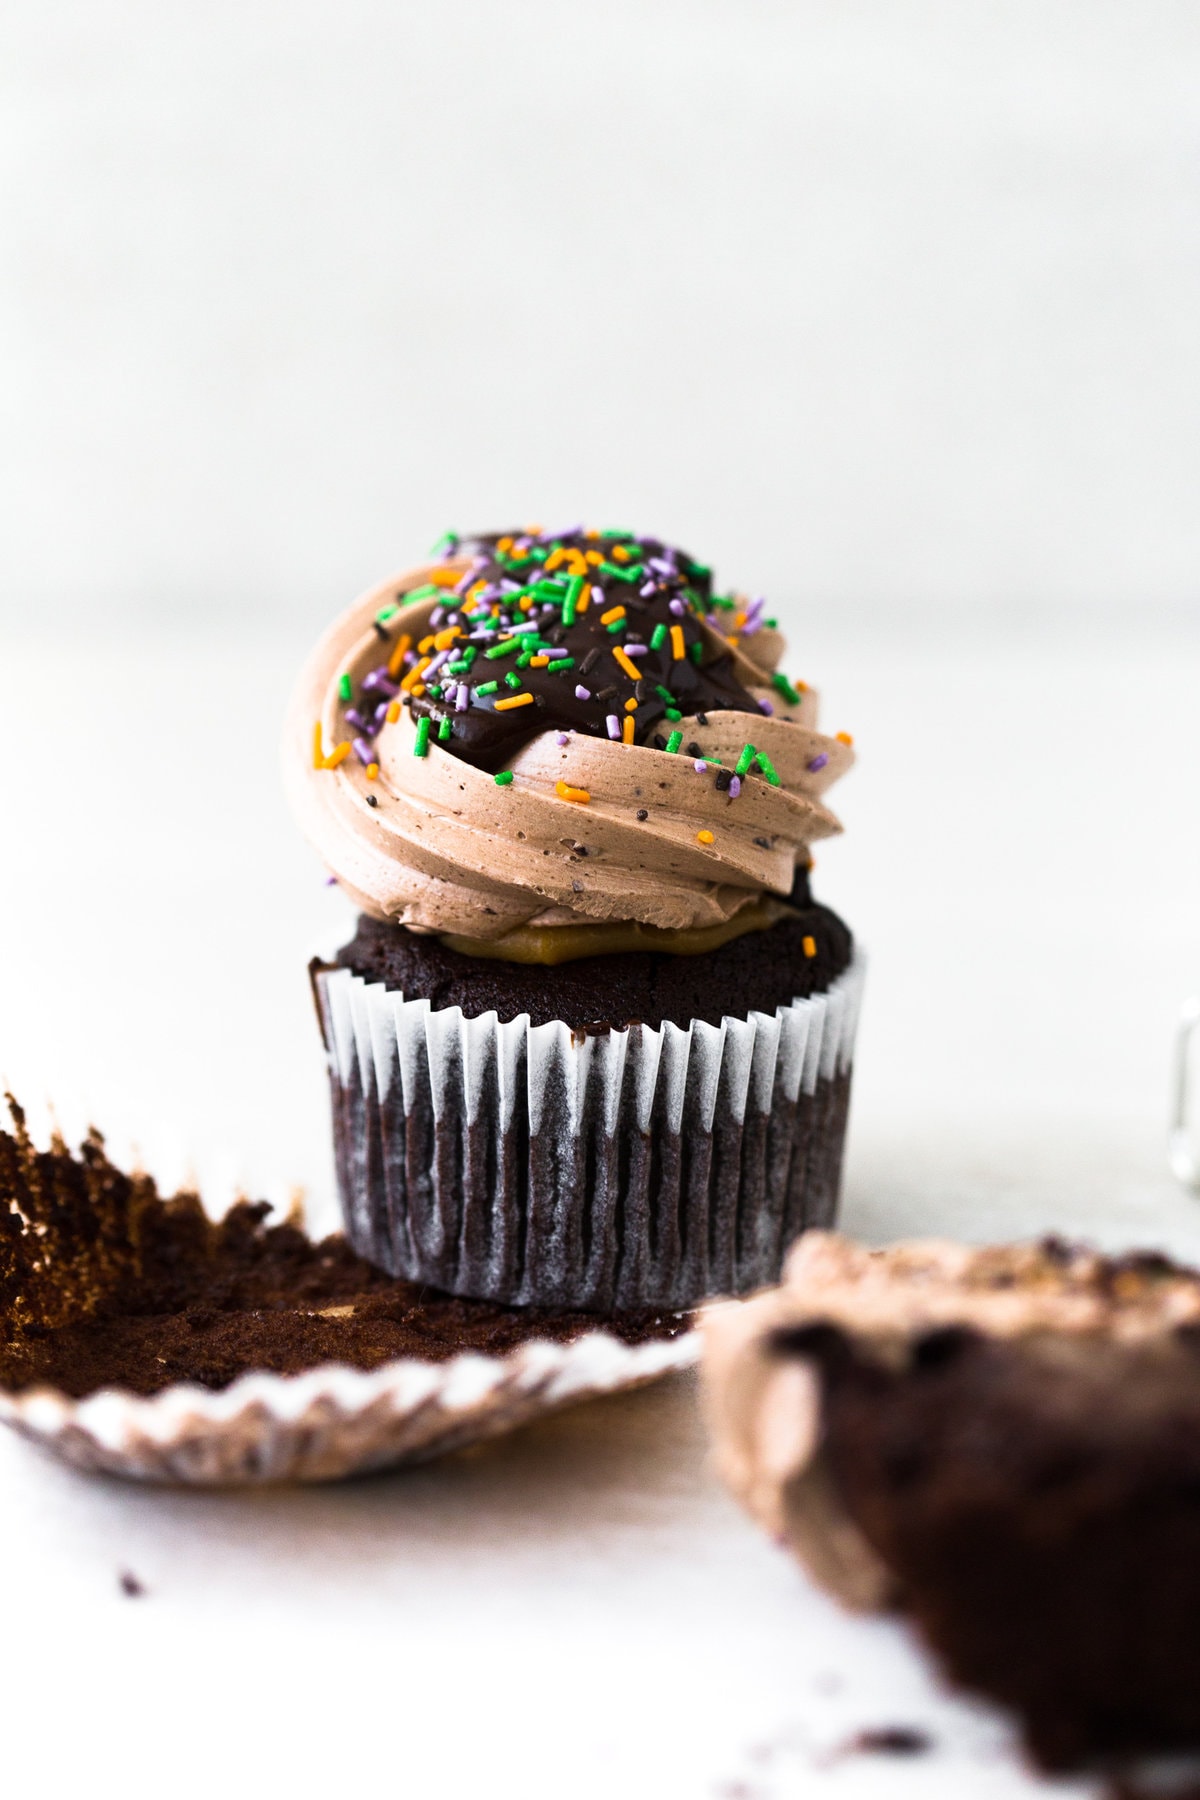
284 531 853 940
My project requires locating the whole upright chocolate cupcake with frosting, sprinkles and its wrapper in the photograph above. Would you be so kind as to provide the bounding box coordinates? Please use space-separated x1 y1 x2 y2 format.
284 531 862 1312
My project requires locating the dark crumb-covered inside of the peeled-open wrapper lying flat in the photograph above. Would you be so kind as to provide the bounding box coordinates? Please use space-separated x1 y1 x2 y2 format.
0 1096 691 1399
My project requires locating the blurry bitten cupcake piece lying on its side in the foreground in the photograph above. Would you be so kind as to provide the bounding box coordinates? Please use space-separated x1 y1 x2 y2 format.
705 1231 1200 1769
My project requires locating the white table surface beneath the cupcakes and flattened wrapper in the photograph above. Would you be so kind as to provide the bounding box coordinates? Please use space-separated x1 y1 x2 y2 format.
0 625 1200 1800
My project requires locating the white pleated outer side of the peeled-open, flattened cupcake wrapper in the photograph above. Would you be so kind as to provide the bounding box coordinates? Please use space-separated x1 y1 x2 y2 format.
0 1332 700 1487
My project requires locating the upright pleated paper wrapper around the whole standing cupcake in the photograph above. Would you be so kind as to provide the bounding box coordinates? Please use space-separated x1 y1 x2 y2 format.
315 956 864 1312
